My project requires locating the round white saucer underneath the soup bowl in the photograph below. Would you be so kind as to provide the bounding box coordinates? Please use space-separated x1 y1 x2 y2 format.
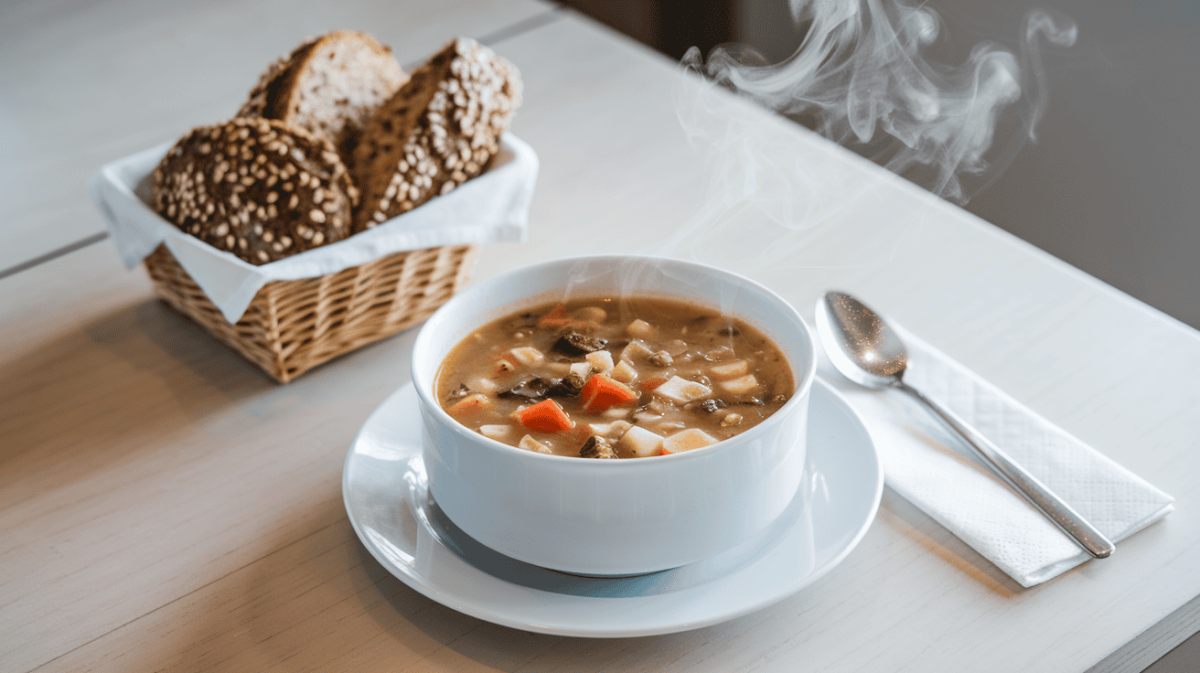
342 380 883 637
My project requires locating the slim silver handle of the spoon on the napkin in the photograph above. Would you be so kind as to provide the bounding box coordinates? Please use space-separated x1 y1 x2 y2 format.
894 381 1116 559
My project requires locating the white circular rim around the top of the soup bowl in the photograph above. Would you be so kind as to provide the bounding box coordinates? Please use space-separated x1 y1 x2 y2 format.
409 254 817 470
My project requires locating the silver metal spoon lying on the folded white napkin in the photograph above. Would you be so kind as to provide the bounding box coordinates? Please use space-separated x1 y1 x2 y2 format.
817 292 1116 559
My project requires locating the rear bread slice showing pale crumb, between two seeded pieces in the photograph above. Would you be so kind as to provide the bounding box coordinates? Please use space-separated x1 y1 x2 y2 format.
238 30 408 166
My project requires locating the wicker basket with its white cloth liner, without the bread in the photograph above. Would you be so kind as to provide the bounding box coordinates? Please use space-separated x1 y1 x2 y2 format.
90 134 538 383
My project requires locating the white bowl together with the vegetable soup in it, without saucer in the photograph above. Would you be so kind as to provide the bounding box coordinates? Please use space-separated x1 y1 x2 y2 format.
412 256 816 576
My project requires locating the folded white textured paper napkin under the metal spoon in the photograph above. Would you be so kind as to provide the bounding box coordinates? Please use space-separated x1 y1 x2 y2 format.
817 323 1175 587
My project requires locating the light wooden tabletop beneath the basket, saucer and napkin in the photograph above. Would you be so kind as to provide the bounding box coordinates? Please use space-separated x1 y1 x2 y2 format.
0 0 1200 673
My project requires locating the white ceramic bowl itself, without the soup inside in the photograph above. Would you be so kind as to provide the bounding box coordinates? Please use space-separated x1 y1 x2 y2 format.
412 257 816 576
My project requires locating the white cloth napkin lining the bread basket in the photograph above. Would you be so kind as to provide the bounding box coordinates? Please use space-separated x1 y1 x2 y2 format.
90 133 538 323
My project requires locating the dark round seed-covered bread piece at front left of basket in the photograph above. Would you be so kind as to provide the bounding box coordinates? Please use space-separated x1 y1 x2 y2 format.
152 119 358 264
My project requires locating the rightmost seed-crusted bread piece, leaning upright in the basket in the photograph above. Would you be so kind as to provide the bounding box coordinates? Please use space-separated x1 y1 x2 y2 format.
350 37 521 232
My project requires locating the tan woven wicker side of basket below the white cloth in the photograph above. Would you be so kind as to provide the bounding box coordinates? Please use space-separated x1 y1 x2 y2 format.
144 245 479 383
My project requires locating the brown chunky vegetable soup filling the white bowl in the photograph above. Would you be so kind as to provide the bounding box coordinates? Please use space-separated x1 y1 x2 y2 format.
437 298 796 458
